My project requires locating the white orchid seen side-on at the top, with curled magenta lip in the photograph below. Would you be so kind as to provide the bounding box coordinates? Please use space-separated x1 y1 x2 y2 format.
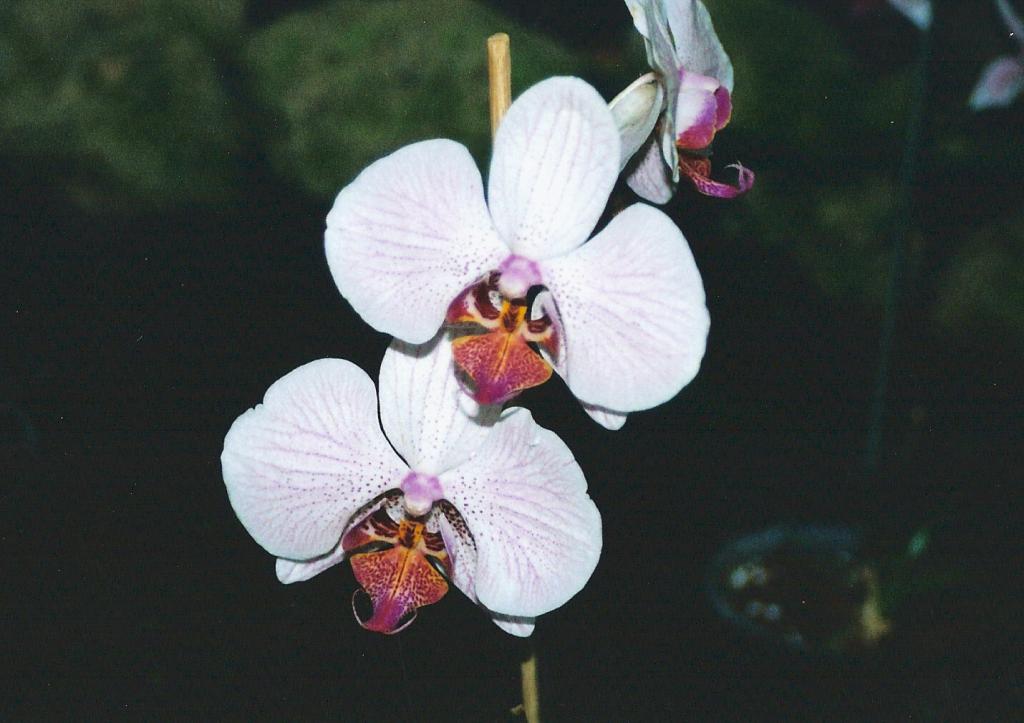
609 0 754 204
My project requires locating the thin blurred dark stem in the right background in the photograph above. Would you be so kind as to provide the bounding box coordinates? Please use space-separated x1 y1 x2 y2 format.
864 21 931 475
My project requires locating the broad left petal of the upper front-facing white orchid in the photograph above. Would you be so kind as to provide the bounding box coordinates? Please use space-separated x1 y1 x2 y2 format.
325 139 508 344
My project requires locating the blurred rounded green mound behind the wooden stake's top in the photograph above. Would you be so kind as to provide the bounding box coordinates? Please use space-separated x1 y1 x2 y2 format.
246 0 583 196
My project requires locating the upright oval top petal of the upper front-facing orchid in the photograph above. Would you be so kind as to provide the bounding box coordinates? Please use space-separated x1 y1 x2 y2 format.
487 78 620 260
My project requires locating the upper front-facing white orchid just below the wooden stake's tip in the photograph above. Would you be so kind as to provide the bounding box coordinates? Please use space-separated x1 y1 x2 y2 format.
326 78 709 429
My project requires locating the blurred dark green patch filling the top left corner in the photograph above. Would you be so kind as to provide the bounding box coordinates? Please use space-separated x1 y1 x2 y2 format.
0 0 243 208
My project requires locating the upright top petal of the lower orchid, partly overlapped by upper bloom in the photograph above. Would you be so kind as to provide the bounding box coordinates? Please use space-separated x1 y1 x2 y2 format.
380 332 501 475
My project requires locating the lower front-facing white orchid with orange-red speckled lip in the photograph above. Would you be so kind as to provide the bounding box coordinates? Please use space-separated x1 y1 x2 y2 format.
221 331 601 636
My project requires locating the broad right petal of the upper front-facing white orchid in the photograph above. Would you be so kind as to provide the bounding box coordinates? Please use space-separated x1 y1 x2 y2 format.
542 204 709 413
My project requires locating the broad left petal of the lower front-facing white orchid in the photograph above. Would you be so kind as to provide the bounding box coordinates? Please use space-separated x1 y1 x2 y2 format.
220 359 408 560
